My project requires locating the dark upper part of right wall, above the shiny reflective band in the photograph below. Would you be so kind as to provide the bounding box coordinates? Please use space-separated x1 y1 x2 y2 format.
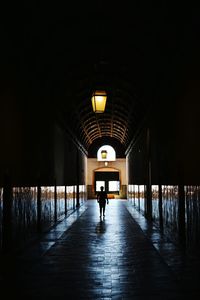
128 87 200 185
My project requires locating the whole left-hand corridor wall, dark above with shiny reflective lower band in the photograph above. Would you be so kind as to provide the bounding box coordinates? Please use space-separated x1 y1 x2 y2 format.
0 97 86 254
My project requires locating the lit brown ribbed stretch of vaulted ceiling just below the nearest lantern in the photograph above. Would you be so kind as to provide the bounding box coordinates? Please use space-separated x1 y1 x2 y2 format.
74 93 144 149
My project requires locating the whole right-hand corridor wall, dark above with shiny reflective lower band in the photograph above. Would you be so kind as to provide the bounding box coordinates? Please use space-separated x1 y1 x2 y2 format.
127 80 200 252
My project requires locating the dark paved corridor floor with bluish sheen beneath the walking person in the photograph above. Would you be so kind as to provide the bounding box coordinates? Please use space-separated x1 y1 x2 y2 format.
0 200 200 300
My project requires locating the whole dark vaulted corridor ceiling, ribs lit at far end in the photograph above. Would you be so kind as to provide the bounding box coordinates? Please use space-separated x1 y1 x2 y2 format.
0 1 197 155
